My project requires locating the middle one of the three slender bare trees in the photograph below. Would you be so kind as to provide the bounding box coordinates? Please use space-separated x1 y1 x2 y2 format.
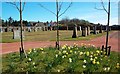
39 0 72 50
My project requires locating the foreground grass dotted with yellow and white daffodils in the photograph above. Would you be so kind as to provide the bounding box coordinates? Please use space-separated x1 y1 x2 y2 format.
2 44 120 73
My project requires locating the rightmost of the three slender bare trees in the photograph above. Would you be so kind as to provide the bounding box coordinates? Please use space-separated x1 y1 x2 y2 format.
95 0 110 54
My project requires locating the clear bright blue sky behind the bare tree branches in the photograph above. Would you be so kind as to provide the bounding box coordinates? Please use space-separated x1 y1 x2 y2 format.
0 2 120 25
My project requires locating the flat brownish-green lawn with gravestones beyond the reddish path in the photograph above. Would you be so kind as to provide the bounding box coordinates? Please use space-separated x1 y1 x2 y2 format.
0 30 112 43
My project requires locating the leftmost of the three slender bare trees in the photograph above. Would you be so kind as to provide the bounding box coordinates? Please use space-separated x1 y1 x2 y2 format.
7 0 27 58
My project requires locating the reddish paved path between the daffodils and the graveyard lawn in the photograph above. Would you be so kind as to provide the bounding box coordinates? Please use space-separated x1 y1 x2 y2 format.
0 31 120 54
